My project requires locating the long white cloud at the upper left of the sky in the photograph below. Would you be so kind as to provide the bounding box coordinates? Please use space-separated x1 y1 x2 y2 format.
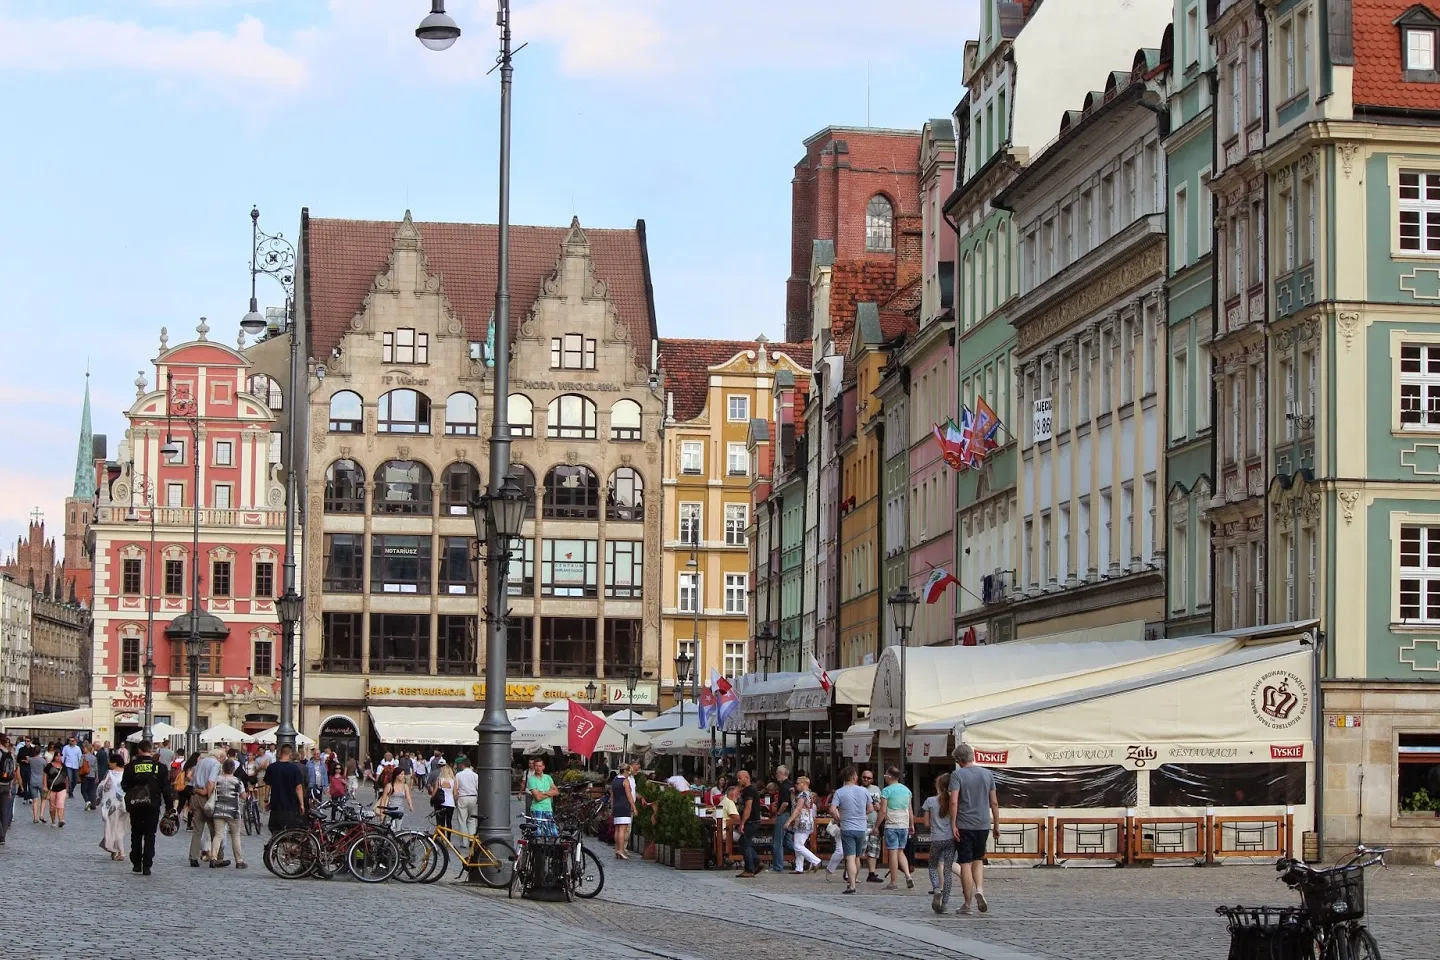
0 16 308 89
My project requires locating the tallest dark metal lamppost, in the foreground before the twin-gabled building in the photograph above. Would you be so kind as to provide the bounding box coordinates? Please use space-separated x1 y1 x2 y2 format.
415 0 526 841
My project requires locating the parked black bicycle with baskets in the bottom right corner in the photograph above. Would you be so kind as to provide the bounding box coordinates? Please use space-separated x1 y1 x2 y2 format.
1215 846 1390 960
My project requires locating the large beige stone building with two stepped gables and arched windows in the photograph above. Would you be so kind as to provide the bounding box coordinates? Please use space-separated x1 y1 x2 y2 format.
298 212 662 748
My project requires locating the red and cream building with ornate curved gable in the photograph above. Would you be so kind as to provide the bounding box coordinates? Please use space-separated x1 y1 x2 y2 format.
89 320 285 741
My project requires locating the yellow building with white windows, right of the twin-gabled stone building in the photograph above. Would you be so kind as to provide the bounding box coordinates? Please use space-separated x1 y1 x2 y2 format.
660 337 809 704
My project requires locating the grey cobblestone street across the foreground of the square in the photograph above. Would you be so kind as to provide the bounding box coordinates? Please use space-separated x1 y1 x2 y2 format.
0 805 1440 960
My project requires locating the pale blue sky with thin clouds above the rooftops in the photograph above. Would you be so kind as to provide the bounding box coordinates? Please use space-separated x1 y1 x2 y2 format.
0 0 978 554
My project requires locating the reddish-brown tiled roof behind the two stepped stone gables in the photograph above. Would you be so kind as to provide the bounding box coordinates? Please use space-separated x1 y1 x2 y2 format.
309 210 655 363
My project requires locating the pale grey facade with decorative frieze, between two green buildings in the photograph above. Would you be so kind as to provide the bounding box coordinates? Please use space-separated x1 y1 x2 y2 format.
996 49 1166 636
